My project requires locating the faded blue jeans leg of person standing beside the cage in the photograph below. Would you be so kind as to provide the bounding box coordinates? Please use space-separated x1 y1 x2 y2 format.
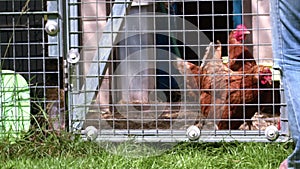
270 0 300 168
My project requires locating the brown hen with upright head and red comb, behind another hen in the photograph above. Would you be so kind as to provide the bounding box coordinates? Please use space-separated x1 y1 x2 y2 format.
228 24 256 71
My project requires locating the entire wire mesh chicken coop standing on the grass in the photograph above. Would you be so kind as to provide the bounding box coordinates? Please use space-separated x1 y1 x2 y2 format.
0 0 289 142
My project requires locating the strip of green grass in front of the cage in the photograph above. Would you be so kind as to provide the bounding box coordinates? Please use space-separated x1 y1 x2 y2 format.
0 132 293 169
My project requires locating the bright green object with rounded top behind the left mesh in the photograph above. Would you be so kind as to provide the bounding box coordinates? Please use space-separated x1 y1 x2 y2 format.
0 70 30 139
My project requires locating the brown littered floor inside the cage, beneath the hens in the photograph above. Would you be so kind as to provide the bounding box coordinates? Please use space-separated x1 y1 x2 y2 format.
84 103 280 130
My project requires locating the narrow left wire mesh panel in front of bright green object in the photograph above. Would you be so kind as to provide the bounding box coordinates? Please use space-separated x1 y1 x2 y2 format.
0 0 64 137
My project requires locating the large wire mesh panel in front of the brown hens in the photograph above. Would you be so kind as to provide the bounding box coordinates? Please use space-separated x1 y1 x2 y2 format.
67 0 288 142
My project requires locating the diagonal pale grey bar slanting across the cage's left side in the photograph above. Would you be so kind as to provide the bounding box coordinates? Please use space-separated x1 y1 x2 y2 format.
72 0 130 130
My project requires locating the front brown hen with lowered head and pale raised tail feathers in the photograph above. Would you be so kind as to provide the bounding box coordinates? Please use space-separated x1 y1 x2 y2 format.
177 42 272 130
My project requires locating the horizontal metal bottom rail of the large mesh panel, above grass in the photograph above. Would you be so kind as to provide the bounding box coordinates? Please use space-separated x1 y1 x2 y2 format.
78 130 289 142
